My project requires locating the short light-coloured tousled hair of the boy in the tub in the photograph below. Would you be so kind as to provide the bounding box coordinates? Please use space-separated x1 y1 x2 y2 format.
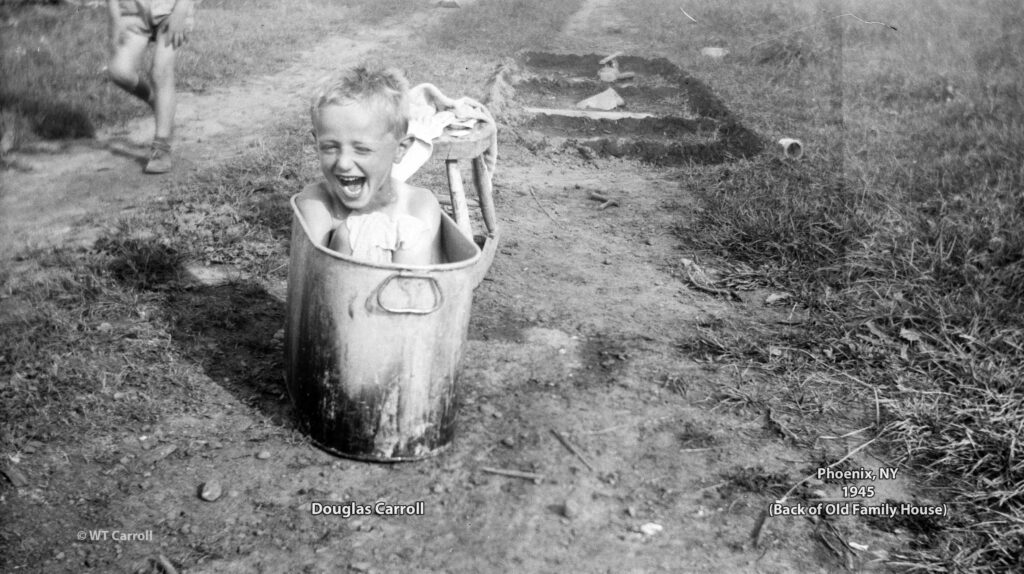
309 64 409 139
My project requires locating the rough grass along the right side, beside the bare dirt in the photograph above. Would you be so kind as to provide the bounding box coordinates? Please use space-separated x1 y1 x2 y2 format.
633 0 1024 572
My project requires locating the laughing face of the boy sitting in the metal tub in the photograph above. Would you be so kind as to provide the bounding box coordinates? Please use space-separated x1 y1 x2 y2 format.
313 102 412 211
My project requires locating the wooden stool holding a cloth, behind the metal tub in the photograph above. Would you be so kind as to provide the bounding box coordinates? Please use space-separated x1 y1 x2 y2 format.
430 122 497 237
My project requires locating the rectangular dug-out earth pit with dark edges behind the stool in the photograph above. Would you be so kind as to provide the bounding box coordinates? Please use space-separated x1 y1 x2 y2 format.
512 52 763 166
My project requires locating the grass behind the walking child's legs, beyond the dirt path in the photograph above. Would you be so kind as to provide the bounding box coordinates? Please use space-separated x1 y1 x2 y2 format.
0 0 418 143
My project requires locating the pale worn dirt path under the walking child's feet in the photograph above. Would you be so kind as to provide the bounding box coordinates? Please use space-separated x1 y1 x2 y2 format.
0 12 415 259
